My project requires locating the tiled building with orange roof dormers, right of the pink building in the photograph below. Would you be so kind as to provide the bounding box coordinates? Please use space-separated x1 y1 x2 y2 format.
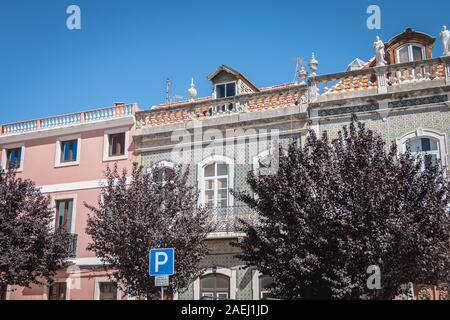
0 29 450 300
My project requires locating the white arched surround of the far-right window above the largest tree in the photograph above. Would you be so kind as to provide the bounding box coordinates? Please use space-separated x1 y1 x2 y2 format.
396 128 448 167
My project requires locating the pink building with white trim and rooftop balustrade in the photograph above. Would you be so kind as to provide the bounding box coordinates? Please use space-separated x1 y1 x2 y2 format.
0 103 138 300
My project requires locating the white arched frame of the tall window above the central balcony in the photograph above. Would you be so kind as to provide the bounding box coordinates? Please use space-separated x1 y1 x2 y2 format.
197 155 234 207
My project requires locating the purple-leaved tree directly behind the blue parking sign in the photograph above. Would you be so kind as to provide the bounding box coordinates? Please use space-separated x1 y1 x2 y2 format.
85 164 211 300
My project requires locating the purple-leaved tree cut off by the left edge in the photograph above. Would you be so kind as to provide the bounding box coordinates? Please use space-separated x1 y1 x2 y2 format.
0 168 70 298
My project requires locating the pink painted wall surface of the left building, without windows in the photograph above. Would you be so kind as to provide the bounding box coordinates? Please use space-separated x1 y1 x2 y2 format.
0 125 134 300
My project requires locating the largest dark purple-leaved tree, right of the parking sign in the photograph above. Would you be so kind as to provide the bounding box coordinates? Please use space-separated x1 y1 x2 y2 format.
235 117 450 299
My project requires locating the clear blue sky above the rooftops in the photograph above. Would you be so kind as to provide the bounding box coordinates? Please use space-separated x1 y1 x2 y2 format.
0 0 450 123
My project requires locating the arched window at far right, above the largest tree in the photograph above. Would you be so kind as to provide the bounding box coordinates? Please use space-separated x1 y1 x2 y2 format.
406 137 441 168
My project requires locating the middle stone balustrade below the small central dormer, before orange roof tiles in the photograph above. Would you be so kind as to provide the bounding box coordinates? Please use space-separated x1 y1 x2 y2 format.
136 85 308 129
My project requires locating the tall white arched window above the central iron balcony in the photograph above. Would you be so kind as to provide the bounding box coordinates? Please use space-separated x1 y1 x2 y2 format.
198 156 234 208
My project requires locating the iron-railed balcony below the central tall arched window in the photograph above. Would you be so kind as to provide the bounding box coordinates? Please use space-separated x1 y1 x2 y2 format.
210 206 258 233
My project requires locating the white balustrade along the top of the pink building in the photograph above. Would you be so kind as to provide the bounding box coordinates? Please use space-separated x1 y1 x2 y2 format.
0 104 136 135
